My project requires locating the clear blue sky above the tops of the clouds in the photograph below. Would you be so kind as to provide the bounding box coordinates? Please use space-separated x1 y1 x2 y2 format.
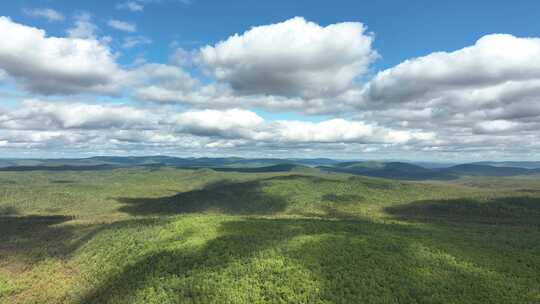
6 0 540 69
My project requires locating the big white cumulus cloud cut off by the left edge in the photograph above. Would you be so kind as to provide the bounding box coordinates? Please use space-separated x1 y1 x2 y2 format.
0 17 121 95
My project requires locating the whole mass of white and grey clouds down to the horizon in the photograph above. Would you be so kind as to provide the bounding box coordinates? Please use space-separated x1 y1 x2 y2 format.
0 16 540 158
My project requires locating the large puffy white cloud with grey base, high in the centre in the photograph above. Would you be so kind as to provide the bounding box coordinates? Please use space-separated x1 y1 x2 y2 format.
199 17 377 97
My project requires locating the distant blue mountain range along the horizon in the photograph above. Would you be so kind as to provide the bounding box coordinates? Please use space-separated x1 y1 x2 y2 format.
0 156 540 180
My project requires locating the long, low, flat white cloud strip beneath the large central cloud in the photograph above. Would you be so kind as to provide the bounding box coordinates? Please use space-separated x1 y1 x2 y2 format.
171 109 435 145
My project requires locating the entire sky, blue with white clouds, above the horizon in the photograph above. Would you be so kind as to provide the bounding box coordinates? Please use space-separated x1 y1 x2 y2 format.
0 0 540 161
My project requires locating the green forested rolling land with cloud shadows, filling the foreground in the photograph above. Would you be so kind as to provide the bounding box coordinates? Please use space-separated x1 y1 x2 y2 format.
0 164 540 304
